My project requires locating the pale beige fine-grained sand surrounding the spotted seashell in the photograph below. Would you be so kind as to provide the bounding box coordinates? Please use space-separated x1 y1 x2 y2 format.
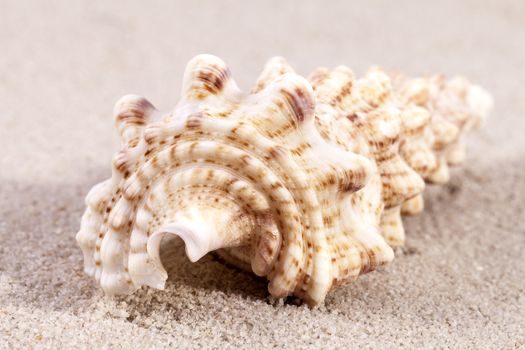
0 0 525 349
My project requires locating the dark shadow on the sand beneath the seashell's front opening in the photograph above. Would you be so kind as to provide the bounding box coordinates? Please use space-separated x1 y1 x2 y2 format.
117 237 269 320
